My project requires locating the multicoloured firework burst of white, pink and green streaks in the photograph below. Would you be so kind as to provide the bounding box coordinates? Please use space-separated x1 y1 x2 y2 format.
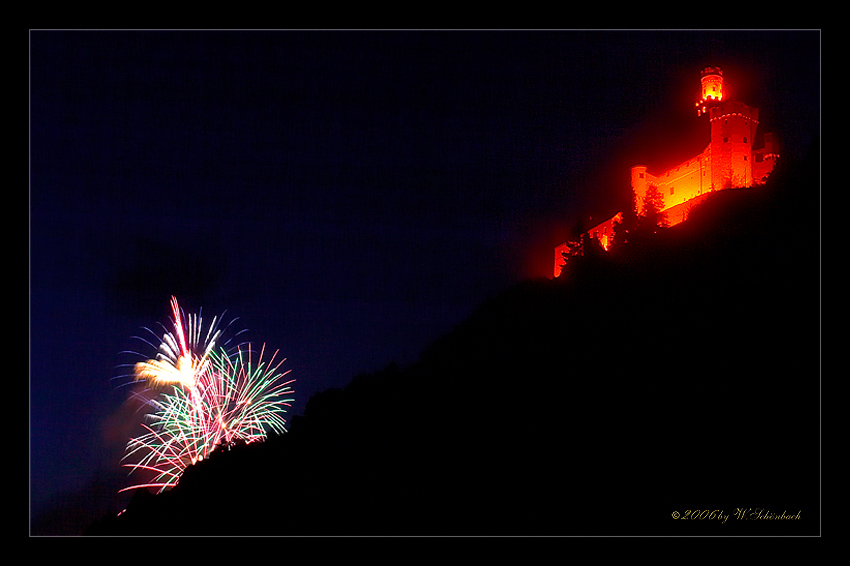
121 297 295 491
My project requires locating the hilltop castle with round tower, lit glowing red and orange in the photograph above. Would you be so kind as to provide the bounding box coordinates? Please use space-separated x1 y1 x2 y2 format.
554 67 779 277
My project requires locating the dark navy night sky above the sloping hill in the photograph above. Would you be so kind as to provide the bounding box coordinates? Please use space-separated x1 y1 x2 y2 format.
29 31 821 536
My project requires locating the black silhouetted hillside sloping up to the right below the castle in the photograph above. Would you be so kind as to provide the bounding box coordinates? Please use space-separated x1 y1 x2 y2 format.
84 142 820 536
